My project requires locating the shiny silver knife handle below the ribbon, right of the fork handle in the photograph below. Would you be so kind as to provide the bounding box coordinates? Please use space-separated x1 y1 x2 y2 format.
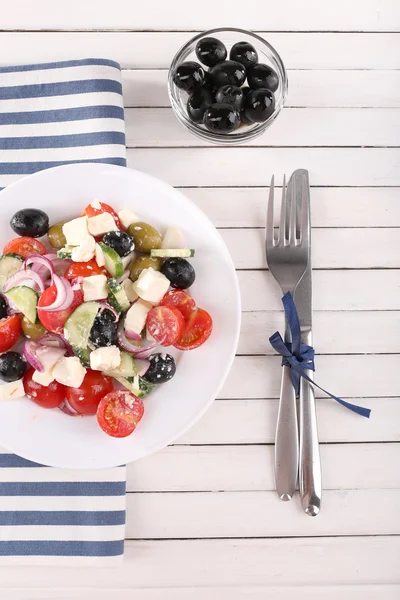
299 370 322 517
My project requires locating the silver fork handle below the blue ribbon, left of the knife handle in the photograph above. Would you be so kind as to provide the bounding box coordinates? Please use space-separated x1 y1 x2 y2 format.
275 367 299 501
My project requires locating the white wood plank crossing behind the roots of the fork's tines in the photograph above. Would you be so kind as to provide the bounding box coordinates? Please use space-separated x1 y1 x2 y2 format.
220 229 400 269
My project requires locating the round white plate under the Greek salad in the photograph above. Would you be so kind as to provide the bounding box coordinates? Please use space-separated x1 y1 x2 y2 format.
0 164 240 469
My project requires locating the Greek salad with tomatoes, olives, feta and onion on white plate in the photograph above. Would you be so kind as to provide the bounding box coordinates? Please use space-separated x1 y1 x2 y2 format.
0 200 212 437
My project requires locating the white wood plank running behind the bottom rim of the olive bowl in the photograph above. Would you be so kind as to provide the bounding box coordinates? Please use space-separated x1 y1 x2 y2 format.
125 108 400 148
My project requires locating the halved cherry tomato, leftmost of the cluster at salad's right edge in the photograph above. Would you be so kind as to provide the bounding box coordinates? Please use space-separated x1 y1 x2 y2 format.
146 306 185 346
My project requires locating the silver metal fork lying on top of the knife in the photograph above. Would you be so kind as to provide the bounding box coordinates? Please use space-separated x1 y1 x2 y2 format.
265 177 308 501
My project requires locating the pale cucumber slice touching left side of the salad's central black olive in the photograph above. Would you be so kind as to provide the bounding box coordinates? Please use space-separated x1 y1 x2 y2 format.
64 302 100 364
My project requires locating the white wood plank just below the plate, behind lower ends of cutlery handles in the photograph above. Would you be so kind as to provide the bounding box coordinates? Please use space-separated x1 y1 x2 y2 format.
127 444 400 492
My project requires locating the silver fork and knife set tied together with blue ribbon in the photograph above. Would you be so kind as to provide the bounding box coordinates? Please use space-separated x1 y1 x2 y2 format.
265 169 322 516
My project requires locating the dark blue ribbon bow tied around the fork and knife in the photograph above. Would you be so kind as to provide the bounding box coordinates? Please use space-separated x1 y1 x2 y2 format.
269 292 371 419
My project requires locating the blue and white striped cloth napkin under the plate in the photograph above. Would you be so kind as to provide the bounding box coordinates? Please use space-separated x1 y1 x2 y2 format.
0 59 126 565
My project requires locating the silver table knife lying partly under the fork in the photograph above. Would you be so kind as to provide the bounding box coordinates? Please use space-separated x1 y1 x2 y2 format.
292 169 322 517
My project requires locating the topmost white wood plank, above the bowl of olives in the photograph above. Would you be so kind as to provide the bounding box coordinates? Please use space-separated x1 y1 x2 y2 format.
1 0 400 31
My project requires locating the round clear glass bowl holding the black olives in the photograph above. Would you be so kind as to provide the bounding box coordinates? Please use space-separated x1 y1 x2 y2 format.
168 27 288 145
